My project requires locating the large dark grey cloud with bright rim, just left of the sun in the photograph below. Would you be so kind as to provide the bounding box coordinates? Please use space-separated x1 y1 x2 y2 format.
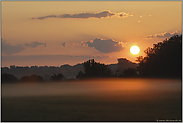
81 38 124 53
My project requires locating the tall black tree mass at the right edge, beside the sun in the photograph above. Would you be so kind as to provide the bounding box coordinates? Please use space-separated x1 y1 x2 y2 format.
136 35 182 78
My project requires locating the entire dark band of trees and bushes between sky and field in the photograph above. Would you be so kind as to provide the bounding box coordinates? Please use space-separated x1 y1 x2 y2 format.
1 35 182 82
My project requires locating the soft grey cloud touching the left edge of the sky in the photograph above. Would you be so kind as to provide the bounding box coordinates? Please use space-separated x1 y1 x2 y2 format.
1 39 25 55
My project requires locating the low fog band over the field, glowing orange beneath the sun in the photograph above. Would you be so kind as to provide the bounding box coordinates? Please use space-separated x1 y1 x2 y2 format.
2 78 182 99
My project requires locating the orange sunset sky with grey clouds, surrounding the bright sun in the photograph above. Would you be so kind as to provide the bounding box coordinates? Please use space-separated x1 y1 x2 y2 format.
1 1 182 67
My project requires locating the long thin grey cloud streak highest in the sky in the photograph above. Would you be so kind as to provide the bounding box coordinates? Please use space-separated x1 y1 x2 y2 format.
32 10 133 20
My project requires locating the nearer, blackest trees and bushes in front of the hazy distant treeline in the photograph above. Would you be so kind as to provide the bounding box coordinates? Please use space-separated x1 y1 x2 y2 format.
1 35 182 82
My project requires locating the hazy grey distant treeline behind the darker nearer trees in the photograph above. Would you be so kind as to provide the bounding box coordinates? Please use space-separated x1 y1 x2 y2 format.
1 58 138 81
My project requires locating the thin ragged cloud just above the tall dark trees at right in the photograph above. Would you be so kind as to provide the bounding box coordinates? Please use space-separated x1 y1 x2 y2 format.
143 31 181 39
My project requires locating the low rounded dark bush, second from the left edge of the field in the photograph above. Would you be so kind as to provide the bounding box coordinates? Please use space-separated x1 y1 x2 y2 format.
20 74 44 82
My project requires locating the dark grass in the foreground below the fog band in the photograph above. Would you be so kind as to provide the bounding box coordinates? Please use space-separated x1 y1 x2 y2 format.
1 93 182 122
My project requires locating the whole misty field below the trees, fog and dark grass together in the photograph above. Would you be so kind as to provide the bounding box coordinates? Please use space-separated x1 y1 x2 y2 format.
1 79 182 122
